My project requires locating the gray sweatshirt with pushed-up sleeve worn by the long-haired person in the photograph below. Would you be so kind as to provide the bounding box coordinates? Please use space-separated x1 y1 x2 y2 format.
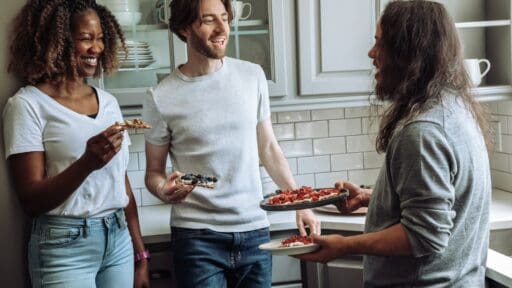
364 95 492 287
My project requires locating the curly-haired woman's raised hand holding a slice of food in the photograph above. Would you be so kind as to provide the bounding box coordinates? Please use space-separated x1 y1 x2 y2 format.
81 125 124 170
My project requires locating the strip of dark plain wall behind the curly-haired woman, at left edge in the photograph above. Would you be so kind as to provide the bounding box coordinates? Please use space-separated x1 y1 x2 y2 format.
0 0 27 288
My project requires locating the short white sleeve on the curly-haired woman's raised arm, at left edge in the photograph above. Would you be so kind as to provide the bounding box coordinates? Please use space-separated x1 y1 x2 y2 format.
3 96 44 159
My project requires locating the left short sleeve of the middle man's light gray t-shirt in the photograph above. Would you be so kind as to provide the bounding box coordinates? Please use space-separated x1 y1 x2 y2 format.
142 89 171 145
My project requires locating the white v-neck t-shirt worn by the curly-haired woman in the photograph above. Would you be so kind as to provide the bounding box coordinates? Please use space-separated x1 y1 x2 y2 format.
3 86 130 217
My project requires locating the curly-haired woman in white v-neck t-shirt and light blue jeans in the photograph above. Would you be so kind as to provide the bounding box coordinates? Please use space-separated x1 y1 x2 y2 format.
3 0 149 288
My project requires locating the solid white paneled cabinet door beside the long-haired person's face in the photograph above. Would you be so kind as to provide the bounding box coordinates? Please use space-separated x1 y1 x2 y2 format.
297 0 380 95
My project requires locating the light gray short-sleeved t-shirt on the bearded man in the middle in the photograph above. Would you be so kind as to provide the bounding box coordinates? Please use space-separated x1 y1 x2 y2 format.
143 57 270 232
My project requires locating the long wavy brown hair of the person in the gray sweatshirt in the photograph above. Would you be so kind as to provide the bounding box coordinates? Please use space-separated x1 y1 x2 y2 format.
375 0 492 152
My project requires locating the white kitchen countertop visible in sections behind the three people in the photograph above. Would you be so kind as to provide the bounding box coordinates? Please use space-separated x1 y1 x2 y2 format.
139 189 512 287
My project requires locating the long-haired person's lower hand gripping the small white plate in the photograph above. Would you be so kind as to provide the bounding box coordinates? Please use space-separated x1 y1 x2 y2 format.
293 234 347 263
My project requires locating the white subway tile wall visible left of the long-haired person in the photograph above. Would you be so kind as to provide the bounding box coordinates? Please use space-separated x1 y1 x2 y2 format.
128 107 384 206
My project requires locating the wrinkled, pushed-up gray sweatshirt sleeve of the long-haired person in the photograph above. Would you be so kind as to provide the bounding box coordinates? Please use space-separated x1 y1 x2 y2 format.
389 122 457 257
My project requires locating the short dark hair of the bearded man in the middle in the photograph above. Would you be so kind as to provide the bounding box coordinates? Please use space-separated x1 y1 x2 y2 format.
169 0 233 42
